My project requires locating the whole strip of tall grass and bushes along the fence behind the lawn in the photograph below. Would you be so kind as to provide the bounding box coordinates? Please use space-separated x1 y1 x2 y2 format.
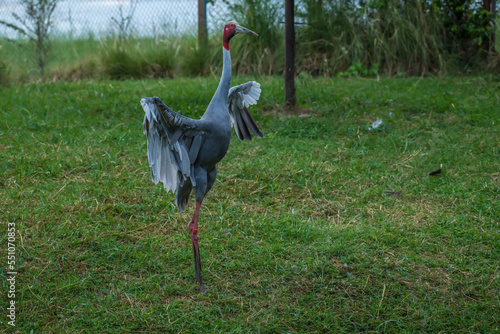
0 0 500 82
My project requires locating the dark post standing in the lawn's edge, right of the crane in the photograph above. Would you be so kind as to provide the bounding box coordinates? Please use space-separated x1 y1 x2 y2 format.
285 0 296 107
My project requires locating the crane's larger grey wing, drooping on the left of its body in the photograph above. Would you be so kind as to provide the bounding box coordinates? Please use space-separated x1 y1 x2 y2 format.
141 96 204 196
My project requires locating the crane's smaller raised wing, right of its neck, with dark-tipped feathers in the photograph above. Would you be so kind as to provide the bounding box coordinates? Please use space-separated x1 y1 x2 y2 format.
227 81 262 140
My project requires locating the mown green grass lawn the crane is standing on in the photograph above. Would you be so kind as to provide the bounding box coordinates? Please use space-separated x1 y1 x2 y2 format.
0 77 500 333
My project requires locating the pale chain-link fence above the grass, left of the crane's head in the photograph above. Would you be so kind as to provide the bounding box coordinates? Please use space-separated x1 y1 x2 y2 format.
0 0 230 38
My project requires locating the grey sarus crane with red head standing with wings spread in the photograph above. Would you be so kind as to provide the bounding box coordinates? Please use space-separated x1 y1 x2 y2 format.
141 21 262 291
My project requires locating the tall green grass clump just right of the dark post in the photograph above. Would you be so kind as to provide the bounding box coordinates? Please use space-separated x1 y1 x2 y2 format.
298 0 453 75
